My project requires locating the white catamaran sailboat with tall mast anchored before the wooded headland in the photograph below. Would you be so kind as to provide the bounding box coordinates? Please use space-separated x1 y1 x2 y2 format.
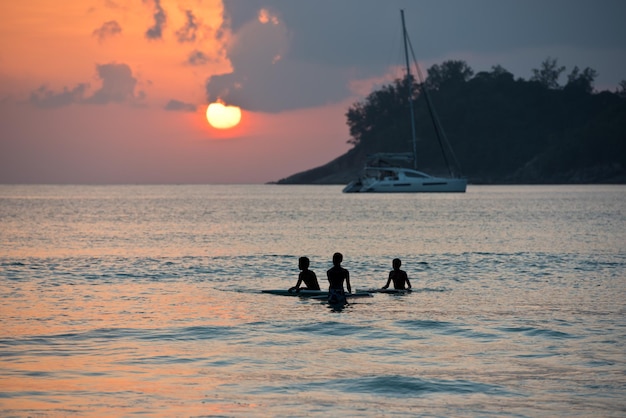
343 10 467 193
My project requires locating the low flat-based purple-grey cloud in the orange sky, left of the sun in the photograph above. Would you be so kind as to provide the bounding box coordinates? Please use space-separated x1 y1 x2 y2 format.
29 64 145 108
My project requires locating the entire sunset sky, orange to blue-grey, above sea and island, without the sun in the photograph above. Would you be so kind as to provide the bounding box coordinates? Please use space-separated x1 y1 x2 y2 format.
0 0 626 184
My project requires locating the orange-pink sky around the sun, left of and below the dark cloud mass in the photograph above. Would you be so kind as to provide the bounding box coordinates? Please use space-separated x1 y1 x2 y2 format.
0 0 350 183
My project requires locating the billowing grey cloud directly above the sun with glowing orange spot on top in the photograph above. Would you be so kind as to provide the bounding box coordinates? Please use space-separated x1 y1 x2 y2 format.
206 8 349 112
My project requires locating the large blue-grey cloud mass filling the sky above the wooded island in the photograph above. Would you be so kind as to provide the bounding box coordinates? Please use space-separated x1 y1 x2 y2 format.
212 0 626 112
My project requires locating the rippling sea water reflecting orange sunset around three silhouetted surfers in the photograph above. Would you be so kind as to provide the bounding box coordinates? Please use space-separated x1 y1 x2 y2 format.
0 185 626 417
